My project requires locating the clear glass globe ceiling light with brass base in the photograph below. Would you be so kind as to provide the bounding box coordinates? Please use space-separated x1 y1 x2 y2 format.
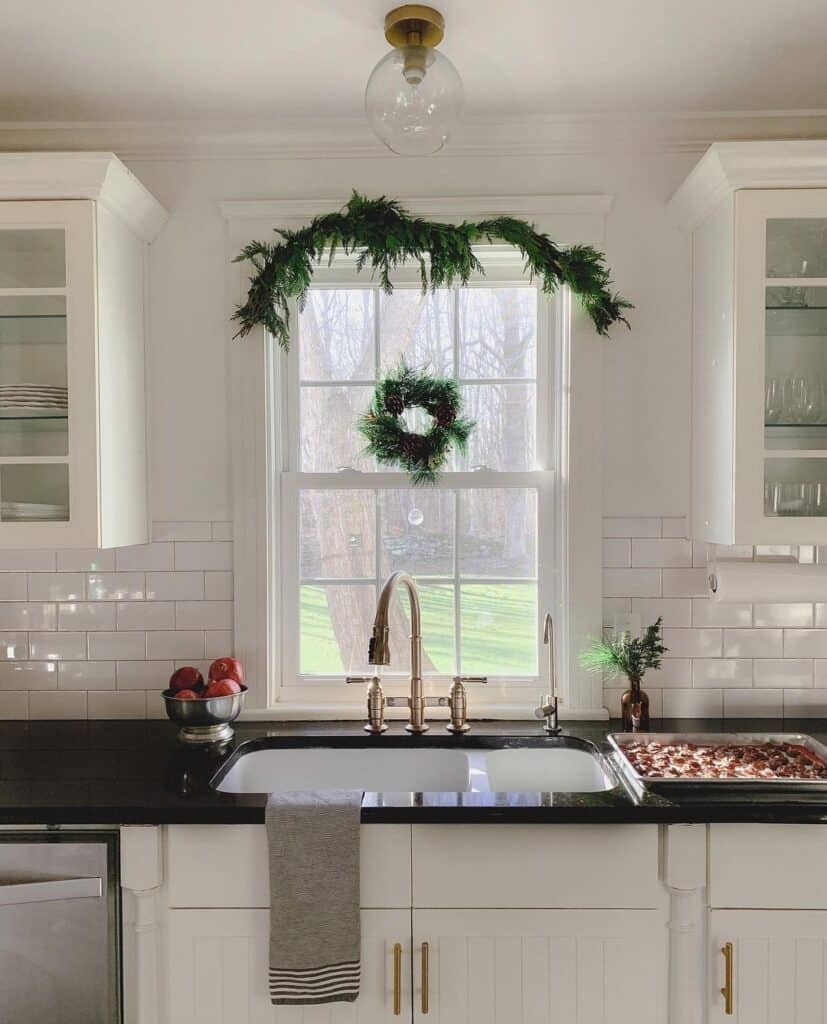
364 4 463 157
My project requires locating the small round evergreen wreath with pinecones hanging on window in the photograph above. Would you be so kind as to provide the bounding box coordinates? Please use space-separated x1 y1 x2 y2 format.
356 361 474 484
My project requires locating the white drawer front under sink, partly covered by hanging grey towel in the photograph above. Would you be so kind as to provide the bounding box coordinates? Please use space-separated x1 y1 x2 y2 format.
166 825 410 907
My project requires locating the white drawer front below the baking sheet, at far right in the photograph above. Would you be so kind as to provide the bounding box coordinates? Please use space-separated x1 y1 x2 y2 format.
709 824 827 910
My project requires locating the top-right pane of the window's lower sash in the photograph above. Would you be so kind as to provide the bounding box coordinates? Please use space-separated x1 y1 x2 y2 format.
458 488 537 578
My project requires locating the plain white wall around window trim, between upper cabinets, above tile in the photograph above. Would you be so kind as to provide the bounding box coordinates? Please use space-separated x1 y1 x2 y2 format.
129 145 699 520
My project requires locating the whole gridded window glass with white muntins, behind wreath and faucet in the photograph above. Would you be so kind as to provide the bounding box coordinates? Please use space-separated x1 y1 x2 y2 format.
282 283 552 683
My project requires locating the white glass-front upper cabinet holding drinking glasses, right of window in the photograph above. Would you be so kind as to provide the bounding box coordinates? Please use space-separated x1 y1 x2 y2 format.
671 141 827 545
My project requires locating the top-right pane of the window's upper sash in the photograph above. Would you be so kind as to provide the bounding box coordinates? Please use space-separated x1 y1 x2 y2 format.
459 288 537 378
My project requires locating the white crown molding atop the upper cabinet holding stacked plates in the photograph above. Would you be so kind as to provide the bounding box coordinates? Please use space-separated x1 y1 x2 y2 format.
0 153 167 243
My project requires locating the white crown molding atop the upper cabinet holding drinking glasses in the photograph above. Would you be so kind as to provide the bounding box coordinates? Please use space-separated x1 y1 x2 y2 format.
669 139 827 230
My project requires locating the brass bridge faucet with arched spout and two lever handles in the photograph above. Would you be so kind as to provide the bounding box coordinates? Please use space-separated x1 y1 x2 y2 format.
347 571 488 732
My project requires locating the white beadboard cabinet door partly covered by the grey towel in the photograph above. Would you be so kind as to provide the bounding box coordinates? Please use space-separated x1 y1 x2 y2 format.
168 910 410 1024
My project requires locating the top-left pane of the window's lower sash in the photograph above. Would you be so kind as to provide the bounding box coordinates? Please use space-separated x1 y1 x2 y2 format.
300 490 376 580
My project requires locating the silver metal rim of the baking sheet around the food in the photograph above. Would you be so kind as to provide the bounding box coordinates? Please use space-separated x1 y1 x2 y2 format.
606 732 827 791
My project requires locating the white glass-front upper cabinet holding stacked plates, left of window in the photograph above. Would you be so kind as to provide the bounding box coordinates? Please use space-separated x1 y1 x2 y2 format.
0 154 166 548
